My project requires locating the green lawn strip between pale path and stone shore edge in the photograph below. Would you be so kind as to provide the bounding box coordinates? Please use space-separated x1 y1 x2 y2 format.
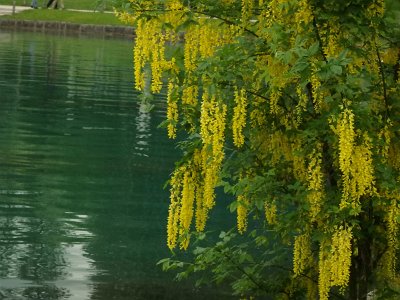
0 9 126 26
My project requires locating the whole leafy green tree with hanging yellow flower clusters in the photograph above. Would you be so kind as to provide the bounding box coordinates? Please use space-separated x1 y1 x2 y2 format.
118 0 400 299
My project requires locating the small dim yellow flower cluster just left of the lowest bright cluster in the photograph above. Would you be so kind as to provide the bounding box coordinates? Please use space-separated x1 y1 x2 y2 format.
293 233 312 276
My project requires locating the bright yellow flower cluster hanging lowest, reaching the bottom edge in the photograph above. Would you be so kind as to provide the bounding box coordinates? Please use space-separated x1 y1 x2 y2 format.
318 226 353 300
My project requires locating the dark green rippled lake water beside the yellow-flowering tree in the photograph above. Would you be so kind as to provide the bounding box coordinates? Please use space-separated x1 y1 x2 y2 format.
0 30 233 300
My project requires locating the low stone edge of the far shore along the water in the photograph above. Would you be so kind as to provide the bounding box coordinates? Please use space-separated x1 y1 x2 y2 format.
0 19 135 38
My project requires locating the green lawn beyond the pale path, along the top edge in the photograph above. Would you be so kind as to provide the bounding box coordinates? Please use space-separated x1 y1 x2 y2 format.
0 0 112 10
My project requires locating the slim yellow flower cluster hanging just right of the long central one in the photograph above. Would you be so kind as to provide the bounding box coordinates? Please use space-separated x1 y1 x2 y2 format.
232 89 247 148
